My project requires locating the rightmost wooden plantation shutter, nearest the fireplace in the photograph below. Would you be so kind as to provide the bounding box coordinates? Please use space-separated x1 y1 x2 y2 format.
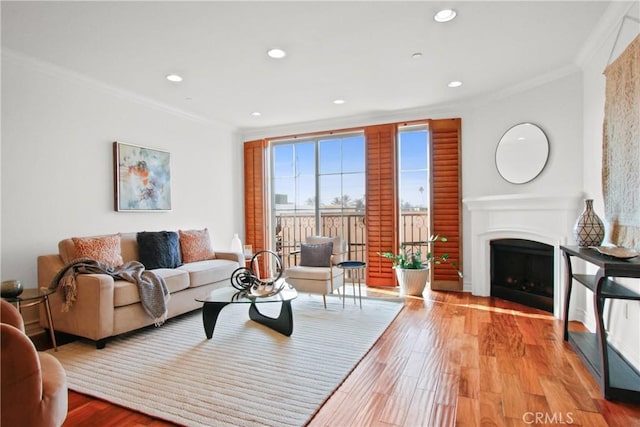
429 119 462 290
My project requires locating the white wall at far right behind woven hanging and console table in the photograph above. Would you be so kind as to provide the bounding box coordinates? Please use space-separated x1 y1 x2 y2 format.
581 3 640 369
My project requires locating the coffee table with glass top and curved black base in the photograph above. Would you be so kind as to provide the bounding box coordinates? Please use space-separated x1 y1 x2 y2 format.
196 284 298 339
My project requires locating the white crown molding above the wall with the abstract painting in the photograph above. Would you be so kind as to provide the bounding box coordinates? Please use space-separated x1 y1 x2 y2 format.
2 47 236 130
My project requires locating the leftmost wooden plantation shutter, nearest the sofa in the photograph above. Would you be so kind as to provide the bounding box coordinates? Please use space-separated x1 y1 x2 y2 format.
244 140 267 270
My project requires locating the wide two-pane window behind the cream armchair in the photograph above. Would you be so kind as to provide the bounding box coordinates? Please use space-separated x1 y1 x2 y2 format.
271 133 365 265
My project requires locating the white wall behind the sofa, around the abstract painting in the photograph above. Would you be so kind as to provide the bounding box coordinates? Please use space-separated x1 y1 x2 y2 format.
0 51 244 306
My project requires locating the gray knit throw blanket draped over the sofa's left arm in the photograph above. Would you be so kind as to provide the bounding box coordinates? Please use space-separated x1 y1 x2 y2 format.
49 258 170 326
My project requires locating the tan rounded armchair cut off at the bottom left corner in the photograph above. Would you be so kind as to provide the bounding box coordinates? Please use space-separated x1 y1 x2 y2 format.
0 300 68 427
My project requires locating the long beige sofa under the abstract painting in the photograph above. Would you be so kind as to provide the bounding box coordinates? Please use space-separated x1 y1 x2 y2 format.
38 233 245 348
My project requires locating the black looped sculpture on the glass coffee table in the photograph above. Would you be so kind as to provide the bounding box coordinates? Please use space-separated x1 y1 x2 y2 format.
231 250 285 298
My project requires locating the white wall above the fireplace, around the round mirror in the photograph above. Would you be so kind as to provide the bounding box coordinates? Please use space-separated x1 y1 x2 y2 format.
462 72 582 197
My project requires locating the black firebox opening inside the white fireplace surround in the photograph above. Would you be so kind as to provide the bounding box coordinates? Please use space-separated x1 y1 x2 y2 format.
490 239 554 313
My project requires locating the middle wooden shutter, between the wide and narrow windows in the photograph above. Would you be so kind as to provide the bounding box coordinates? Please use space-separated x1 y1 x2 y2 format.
365 124 398 286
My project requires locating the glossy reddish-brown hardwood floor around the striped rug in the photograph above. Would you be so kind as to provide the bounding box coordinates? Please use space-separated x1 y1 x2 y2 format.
42 288 640 427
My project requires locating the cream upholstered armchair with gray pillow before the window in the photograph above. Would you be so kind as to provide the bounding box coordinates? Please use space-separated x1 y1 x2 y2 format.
284 236 347 309
